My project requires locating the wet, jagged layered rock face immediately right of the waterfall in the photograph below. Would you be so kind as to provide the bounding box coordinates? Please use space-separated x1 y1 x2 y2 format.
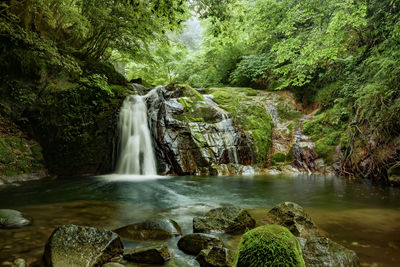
147 85 253 175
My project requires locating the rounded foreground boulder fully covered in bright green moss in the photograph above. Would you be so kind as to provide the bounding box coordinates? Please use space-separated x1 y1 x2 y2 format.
235 225 305 267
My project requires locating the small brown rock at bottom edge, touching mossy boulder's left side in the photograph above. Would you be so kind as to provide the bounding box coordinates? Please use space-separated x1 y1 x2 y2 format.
196 247 234 267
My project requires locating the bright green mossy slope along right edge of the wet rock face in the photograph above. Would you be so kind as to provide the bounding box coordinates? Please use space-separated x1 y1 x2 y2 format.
209 88 272 165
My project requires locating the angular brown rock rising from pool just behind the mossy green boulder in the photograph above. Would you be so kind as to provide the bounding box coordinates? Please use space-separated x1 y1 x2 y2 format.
267 202 319 238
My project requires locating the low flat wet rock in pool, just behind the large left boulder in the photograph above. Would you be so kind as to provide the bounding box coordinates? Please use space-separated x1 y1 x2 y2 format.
114 219 182 240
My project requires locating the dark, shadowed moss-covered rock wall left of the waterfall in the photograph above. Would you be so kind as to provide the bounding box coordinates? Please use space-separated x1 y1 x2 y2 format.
29 80 129 175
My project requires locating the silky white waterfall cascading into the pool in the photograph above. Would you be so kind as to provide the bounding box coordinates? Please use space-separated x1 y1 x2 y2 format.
116 95 157 175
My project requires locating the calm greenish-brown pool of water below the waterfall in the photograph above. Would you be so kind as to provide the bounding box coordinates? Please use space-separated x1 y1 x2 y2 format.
0 175 400 266
